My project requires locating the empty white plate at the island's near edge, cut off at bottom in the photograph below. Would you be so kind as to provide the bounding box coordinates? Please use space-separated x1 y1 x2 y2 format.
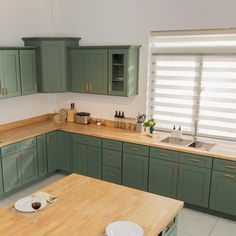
106 221 143 236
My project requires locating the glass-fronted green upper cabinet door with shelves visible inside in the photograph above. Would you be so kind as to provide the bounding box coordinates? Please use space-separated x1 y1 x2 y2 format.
108 49 128 96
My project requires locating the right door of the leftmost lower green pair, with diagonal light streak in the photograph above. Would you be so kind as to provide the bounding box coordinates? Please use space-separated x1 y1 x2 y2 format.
21 148 38 184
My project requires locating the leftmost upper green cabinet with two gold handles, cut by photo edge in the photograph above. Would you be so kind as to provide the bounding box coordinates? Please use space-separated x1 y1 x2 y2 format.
0 49 21 98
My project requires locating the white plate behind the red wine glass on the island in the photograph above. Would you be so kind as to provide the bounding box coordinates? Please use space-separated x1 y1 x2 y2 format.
15 196 47 212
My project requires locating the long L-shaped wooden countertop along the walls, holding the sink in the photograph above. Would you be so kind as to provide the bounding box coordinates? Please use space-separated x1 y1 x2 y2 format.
0 120 236 161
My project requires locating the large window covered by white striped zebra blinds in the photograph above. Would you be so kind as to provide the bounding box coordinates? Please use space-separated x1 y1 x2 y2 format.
148 30 236 139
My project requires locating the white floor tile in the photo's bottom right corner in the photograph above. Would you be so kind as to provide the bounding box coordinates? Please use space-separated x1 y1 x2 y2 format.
210 218 236 236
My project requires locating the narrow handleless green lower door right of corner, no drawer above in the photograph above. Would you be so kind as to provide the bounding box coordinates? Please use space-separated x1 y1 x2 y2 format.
57 132 71 172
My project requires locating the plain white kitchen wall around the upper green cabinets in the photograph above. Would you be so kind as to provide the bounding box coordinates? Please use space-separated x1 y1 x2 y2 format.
0 0 236 124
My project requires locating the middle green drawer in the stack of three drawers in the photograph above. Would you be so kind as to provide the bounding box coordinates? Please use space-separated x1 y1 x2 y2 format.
102 149 122 168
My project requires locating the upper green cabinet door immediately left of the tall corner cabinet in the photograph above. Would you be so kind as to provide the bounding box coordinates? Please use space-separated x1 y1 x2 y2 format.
19 50 37 95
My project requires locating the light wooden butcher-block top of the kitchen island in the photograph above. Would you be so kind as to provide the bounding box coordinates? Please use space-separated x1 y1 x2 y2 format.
0 174 183 236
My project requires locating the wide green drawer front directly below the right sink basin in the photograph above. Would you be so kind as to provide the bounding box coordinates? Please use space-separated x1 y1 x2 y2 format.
180 153 212 169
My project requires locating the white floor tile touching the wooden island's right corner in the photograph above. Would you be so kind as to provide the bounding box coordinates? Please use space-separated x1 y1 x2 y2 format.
178 208 219 236
